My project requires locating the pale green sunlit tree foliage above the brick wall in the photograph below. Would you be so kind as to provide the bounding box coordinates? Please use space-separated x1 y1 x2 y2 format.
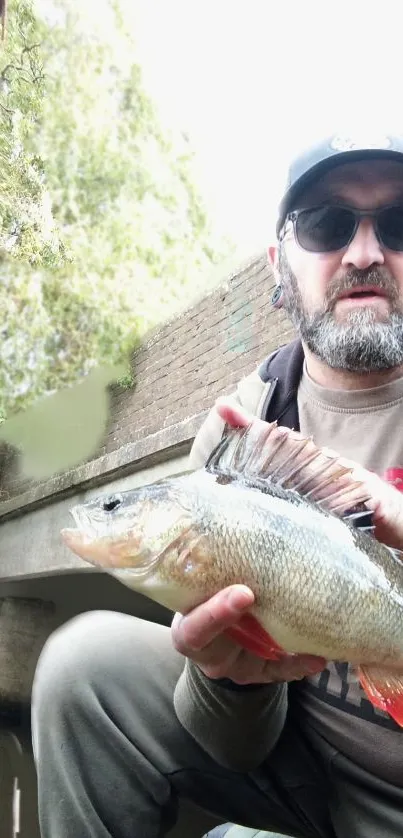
0 0 232 424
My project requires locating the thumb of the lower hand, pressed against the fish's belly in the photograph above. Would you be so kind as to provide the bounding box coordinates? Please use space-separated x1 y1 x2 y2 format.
171 585 254 657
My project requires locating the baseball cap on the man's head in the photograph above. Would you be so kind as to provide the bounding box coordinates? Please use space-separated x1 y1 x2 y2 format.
276 134 403 236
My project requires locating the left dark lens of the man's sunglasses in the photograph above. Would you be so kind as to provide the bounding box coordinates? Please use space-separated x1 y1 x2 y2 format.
296 207 355 253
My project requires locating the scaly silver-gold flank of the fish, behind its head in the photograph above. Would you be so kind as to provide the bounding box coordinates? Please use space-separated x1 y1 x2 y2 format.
153 475 403 662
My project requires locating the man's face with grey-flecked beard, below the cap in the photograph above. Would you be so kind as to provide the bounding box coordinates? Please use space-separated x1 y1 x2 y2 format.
277 161 403 372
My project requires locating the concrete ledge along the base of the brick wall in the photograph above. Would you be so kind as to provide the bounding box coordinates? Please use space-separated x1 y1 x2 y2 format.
0 410 208 522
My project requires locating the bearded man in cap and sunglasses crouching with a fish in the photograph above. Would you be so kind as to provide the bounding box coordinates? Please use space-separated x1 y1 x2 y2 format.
33 137 403 838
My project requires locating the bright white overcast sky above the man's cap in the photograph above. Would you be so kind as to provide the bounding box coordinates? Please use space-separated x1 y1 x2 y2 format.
127 0 403 257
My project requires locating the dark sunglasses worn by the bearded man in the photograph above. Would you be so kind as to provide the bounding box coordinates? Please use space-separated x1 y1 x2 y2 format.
282 204 403 253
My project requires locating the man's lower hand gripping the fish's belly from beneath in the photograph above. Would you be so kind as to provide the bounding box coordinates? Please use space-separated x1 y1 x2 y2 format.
171 585 326 684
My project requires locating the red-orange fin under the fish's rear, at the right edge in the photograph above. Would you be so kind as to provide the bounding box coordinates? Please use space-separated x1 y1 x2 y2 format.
357 666 403 727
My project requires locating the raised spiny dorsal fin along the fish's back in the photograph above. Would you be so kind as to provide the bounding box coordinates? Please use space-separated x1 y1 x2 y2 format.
205 421 372 520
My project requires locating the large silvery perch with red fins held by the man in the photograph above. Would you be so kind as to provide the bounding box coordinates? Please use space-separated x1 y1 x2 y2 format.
62 423 403 727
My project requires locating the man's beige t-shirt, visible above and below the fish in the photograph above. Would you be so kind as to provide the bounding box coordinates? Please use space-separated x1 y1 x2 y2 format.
295 367 403 785
